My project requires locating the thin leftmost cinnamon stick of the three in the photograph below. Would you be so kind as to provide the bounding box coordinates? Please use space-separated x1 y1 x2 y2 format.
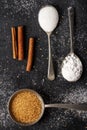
11 27 17 59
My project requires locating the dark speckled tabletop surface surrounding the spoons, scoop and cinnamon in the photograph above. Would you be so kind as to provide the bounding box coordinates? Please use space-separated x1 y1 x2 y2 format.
0 0 87 130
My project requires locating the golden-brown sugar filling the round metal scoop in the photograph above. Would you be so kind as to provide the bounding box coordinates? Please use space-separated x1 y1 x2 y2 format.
10 90 42 124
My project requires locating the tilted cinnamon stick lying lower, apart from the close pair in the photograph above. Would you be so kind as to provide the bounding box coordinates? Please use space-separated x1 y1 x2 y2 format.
26 37 34 72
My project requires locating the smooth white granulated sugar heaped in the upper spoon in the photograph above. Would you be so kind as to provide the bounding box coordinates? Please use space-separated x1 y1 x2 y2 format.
38 6 59 32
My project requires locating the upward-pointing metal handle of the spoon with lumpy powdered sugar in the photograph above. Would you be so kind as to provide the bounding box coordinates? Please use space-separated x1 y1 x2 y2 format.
68 7 74 53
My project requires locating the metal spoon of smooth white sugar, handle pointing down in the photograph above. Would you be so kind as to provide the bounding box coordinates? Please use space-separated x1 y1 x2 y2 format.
38 5 59 80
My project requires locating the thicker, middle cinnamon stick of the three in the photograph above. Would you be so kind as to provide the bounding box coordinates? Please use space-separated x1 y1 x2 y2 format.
18 26 24 60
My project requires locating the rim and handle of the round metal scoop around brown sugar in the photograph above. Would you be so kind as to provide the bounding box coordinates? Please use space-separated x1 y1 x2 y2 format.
8 89 87 126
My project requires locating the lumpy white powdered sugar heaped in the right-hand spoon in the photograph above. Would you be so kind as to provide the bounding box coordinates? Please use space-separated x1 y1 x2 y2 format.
62 53 83 82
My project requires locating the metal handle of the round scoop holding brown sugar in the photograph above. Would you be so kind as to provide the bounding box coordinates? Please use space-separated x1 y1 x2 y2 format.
45 103 87 111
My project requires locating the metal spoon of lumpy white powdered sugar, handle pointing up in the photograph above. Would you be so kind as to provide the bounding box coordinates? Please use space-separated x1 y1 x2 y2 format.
61 7 83 82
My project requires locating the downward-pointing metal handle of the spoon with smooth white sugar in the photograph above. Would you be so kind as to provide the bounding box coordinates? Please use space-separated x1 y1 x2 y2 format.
47 33 55 80
